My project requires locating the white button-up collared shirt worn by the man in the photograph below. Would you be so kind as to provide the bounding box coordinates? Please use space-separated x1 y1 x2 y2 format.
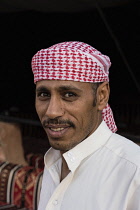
38 121 140 210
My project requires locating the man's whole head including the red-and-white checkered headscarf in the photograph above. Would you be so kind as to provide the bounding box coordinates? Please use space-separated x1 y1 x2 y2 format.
32 42 116 151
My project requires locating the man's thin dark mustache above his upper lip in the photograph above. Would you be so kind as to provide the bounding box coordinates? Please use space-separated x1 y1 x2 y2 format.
42 118 75 128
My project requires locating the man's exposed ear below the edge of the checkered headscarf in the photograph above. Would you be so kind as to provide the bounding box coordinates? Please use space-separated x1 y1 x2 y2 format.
97 82 110 111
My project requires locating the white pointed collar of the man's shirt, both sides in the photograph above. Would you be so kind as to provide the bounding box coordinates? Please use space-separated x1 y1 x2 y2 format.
45 121 112 172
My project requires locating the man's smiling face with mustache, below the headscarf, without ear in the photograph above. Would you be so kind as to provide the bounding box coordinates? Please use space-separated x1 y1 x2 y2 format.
35 80 101 152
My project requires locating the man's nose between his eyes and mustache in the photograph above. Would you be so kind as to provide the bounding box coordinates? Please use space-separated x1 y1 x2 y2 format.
46 97 64 119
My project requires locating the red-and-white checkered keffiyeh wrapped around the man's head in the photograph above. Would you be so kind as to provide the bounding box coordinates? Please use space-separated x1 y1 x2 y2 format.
32 41 117 132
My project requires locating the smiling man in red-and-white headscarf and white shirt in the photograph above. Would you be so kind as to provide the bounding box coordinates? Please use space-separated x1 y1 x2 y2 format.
32 42 140 210
